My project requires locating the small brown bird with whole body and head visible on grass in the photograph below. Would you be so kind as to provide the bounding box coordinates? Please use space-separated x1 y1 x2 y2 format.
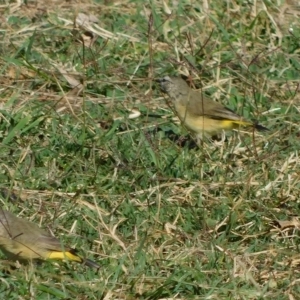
157 76 268 139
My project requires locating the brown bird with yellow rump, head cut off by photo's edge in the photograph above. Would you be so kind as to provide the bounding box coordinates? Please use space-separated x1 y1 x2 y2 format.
0 209 100 269
